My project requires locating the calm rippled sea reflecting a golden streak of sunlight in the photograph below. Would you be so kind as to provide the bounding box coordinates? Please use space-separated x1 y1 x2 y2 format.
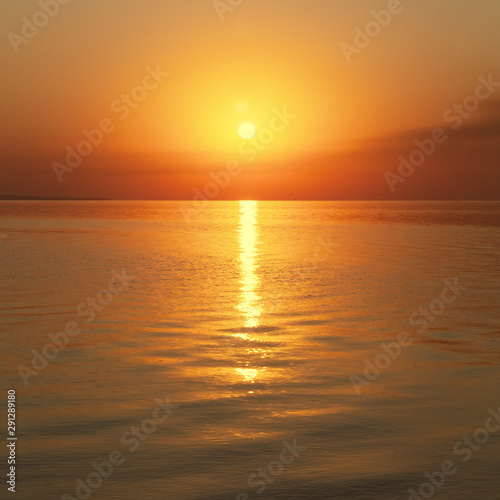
0 202 500 500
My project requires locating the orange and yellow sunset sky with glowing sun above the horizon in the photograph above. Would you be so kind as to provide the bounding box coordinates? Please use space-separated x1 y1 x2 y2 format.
0 0 500 200
